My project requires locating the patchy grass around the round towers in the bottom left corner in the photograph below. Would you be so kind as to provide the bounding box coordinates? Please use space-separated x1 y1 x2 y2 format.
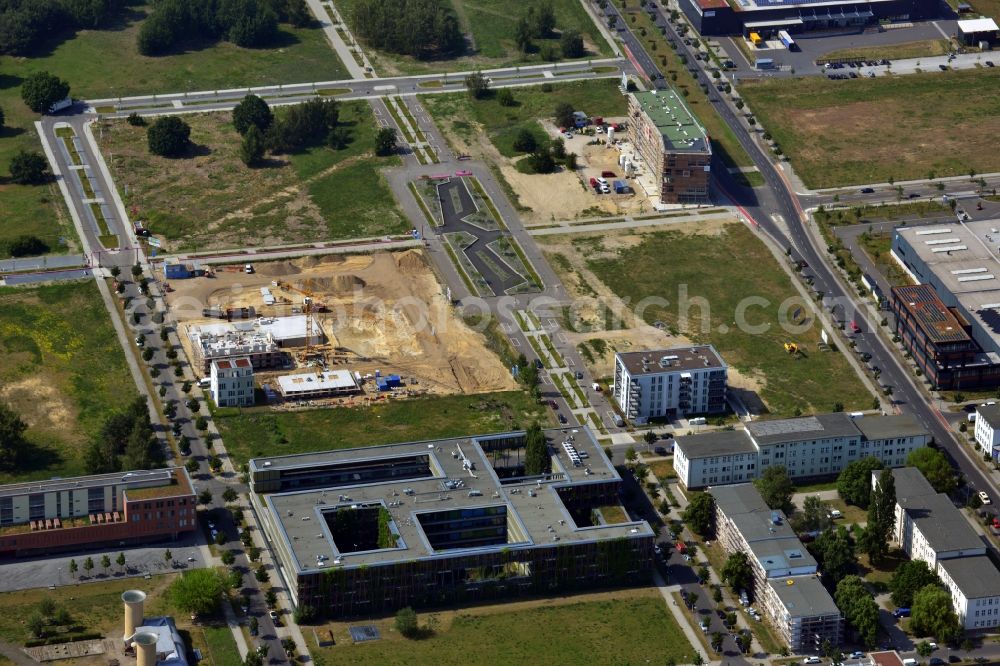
0 572 241 666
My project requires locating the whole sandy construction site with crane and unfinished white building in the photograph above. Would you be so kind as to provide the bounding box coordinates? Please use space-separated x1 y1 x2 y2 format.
167 250 516 406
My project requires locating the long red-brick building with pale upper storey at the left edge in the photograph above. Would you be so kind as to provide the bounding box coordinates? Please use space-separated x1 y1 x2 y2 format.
0 467 197 556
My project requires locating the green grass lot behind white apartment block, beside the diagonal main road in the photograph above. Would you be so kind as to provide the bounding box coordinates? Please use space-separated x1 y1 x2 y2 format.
584 223 871 416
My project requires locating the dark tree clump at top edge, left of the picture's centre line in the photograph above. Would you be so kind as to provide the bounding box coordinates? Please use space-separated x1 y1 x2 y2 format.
350 0 465 60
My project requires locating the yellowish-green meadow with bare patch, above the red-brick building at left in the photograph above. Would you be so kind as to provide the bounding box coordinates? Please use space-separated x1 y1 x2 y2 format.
0 281 136 483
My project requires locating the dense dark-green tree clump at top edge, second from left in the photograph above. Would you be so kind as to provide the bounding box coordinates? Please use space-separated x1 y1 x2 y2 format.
137 0 312 56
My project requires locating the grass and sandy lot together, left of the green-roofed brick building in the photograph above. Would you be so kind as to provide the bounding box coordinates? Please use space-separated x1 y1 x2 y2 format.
420 79 627 224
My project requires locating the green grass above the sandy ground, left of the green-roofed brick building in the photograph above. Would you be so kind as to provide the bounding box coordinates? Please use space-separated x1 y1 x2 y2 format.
420 79 628 157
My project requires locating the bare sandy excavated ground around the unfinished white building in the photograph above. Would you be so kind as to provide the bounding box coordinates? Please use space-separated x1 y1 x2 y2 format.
167 250 516 394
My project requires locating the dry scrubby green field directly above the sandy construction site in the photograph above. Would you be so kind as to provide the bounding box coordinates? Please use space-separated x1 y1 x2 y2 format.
94 102 410 251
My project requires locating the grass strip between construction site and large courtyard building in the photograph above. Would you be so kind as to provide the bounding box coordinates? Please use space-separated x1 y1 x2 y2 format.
215 391 552 463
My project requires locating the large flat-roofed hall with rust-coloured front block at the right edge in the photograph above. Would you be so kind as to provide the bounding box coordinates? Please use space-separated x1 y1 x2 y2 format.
889 220 1000 389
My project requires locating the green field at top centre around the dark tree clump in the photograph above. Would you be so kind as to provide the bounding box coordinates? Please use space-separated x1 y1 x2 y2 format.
336 0 611 76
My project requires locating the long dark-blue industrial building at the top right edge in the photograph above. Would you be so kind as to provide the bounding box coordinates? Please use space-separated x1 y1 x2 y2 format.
679 0 940 38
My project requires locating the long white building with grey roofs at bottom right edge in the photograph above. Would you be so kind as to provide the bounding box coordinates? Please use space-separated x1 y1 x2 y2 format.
872 467 1000 630
